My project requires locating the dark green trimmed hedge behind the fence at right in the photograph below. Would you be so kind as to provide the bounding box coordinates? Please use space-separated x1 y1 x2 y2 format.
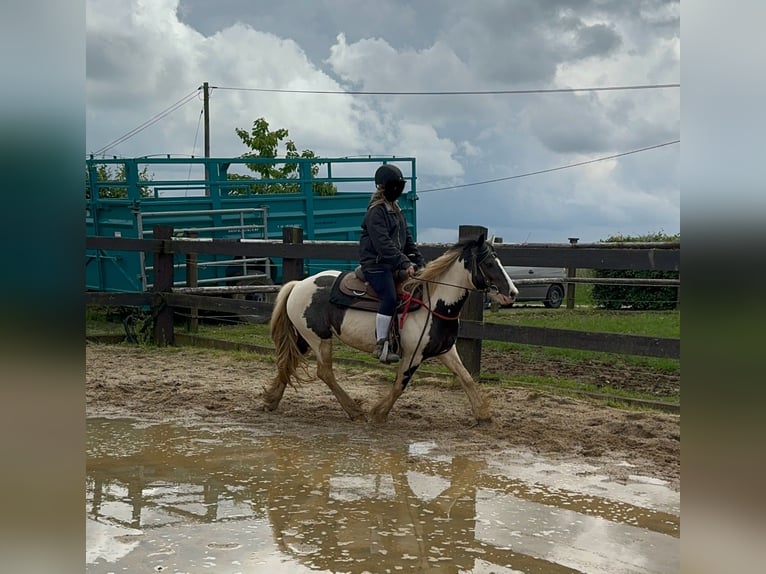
590 232 681 311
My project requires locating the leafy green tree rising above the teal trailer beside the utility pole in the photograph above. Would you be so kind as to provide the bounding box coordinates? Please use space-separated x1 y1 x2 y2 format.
228 118 338 195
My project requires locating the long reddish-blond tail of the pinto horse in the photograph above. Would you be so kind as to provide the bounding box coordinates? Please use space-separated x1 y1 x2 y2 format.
269 281 308 385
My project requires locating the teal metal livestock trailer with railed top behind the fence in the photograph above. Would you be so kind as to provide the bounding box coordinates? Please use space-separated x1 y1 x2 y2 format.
85 156 417 292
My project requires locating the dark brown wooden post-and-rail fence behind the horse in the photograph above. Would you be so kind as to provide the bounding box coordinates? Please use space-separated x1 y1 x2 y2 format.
86 226 680 375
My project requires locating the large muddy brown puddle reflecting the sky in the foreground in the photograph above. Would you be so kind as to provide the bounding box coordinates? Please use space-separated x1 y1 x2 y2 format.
86 418 680 574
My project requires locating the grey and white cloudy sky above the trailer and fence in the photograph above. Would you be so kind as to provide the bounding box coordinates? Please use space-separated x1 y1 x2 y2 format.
86 0 680 243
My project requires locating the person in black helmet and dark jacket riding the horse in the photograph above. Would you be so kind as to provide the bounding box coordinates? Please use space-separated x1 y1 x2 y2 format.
359 164 425 363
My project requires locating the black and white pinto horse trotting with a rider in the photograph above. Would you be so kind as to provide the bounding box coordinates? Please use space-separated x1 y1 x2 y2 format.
263 233 518 424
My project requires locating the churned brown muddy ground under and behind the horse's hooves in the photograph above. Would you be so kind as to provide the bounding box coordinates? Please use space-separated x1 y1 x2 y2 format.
86 343 681 489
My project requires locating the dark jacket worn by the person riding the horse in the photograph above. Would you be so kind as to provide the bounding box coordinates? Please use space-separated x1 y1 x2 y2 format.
359 202 425 271
